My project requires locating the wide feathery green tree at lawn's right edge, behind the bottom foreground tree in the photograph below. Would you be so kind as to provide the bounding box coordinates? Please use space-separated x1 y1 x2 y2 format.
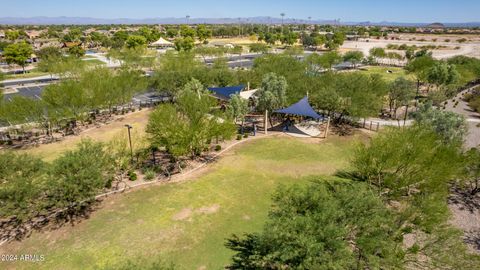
353 125 461 197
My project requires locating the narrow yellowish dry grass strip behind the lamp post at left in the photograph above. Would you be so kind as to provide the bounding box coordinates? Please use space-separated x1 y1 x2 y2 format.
18 109 151 161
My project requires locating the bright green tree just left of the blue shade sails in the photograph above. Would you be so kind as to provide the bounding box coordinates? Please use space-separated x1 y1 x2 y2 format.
147 79 235 160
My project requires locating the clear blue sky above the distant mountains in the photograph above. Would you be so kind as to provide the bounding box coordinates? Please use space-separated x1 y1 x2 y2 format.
0 0 480 22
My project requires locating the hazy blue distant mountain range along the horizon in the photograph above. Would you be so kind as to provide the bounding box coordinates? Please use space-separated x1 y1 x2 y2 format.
0 16 480 27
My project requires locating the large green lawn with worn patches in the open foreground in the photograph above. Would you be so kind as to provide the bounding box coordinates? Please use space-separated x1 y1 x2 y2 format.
0 135 364 269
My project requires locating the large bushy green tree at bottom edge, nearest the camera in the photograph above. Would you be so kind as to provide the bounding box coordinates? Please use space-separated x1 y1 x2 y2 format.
226 180 404 269
